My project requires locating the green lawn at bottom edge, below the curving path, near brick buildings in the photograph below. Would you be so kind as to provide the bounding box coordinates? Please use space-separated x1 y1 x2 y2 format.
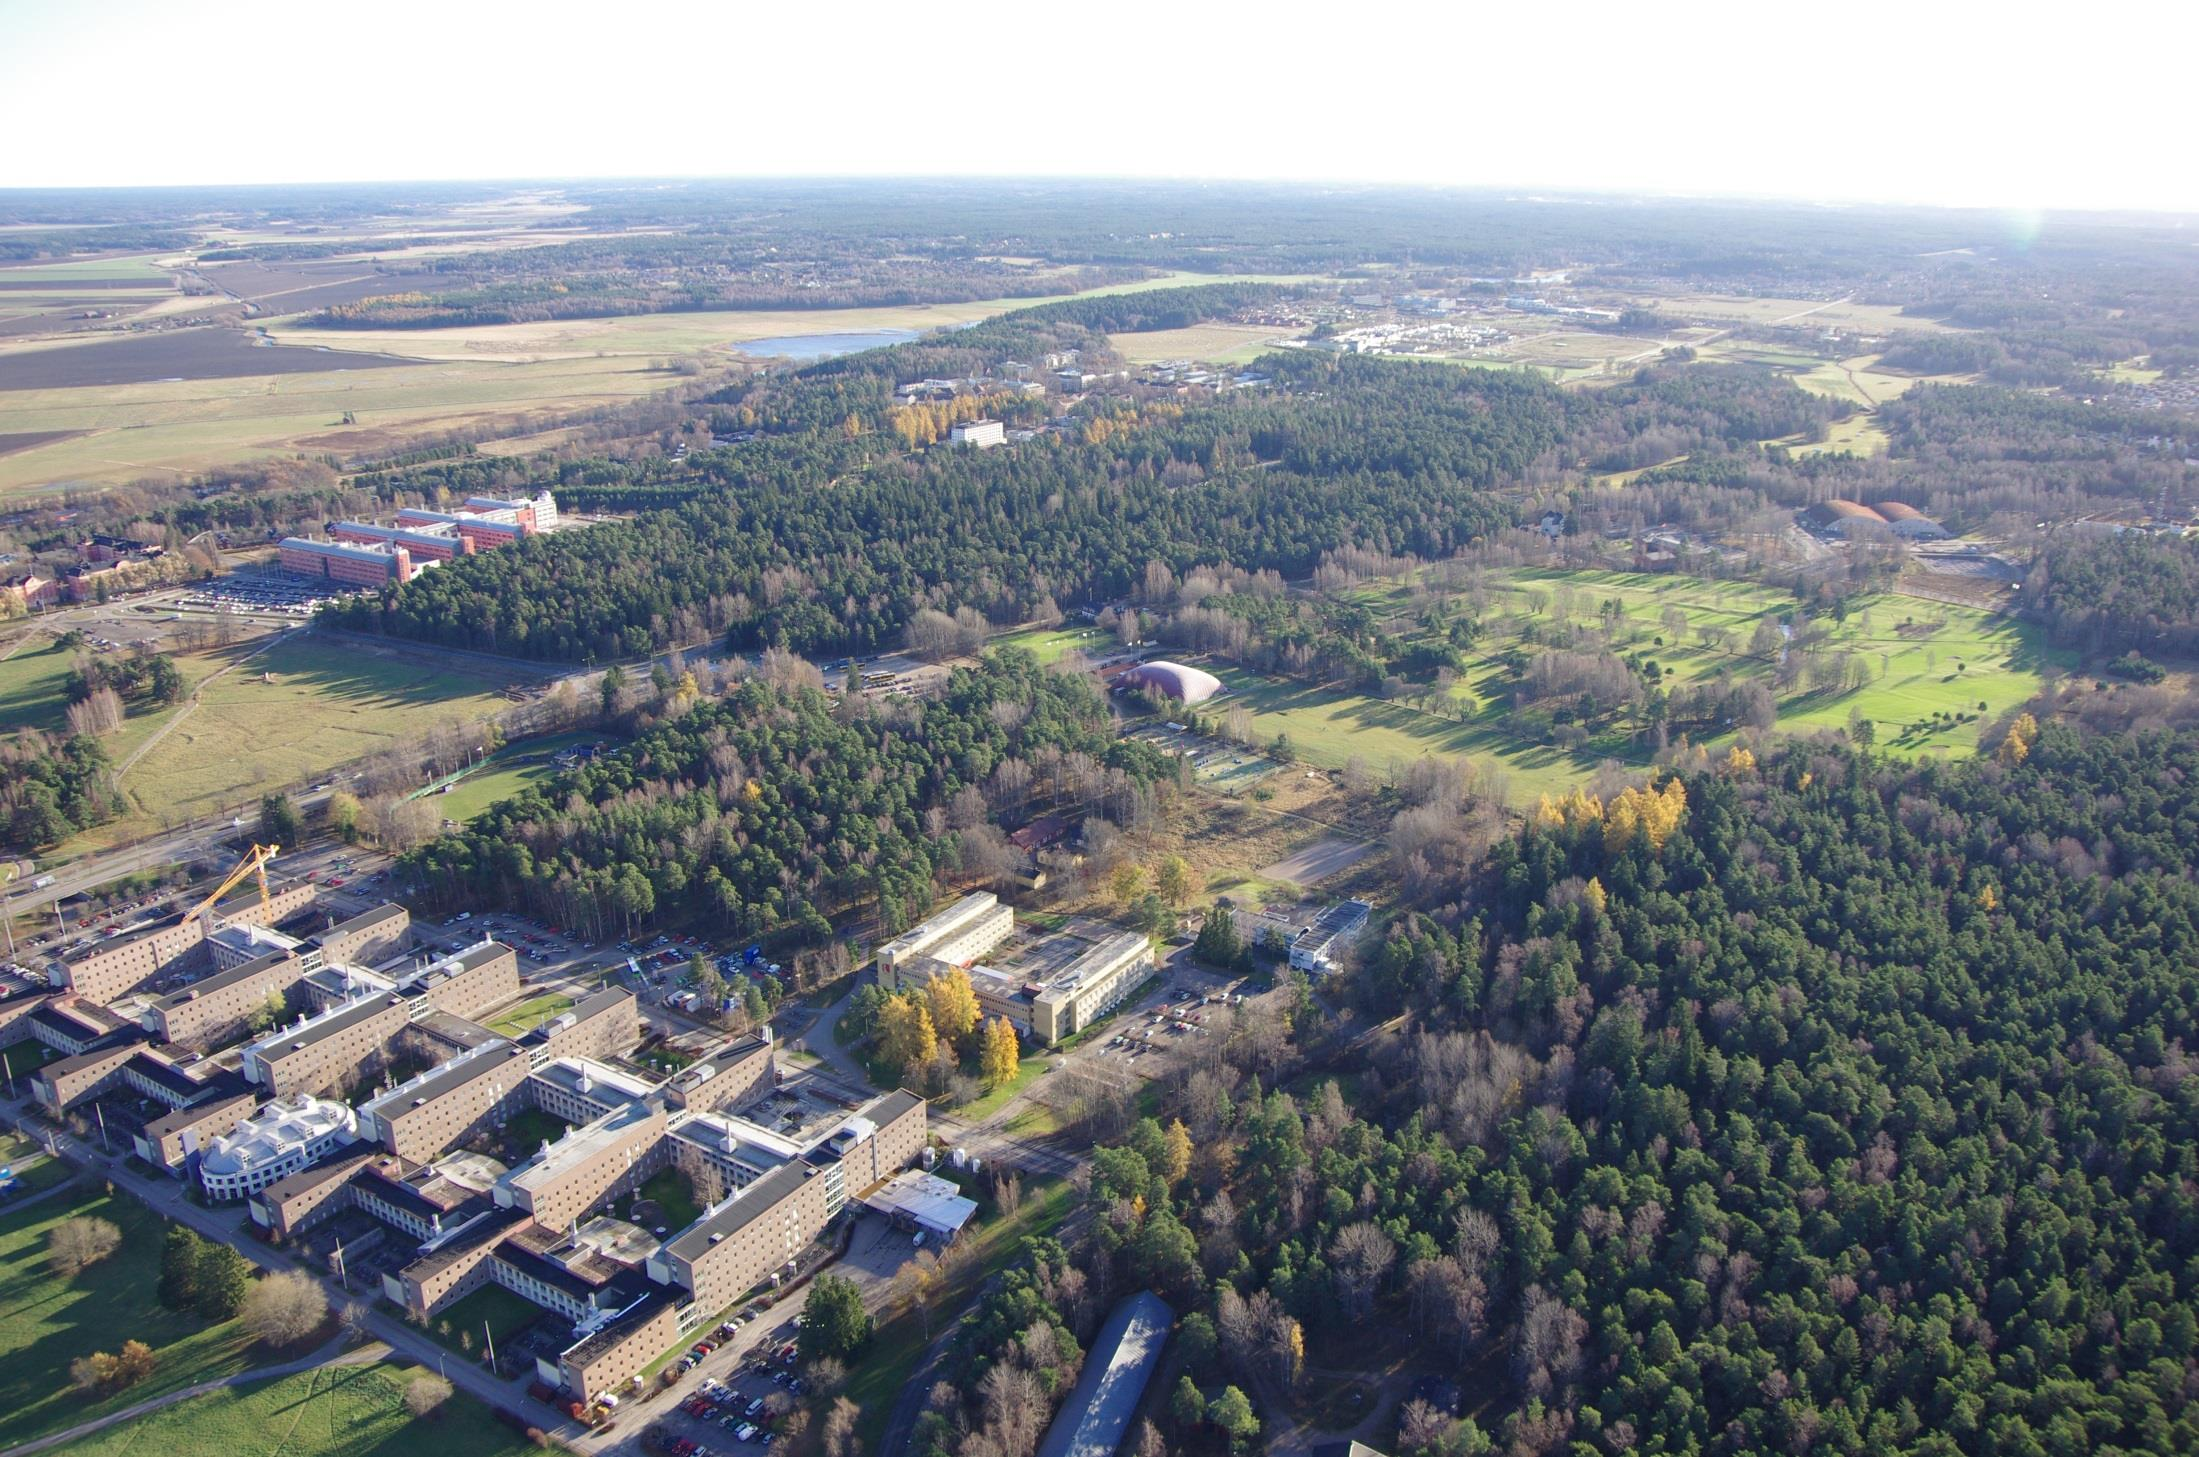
68 1363 534 1457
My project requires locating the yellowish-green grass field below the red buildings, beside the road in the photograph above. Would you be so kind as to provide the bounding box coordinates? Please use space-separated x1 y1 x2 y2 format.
87 633 508 848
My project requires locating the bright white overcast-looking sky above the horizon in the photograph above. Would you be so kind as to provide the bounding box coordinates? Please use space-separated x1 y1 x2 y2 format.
0 0 2199 213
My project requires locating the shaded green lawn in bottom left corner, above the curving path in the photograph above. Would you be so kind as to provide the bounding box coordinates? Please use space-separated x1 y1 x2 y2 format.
0 1191 259 1450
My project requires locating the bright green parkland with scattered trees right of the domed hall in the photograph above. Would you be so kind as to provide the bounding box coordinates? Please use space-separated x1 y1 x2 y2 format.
1214 569 2052 804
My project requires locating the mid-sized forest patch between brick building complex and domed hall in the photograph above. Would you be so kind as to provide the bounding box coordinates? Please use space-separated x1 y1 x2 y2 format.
402 650 1163 941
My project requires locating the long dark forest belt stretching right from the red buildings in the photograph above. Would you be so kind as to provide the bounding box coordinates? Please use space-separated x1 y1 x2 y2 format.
325 307 1845 661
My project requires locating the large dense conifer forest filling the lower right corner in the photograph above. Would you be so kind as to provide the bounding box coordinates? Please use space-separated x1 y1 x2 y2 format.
1091 723 2199 1453
